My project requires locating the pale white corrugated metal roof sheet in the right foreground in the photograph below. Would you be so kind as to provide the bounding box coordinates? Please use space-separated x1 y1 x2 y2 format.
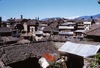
58 42 100 57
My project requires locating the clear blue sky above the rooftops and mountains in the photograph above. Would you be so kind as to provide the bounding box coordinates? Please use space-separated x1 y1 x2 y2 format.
0 0 100 20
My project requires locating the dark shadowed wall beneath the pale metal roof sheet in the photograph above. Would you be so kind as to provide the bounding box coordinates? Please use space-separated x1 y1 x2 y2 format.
66 54 84 68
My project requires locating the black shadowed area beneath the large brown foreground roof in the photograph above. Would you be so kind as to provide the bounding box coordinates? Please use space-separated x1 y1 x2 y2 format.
8 58 41 68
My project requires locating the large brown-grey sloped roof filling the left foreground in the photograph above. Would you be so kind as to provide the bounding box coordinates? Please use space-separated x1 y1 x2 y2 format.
0 42 58 65
